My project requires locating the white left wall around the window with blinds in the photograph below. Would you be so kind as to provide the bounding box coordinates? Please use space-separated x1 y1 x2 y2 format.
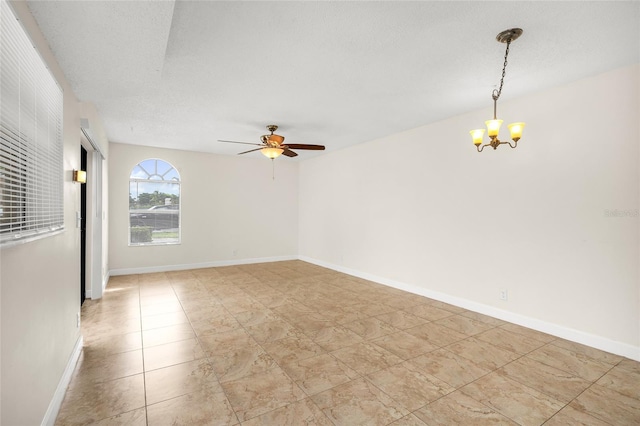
0 2 81 425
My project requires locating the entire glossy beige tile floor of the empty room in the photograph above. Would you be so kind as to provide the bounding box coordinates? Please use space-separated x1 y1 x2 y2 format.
56 261 640 426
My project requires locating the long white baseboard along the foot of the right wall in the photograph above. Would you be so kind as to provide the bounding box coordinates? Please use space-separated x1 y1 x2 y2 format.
299 256 640 361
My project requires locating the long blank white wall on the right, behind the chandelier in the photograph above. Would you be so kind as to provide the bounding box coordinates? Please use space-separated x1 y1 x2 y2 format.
299 65 640 359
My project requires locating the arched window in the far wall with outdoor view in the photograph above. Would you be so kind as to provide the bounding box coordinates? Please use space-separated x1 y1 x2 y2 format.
129 158 180 246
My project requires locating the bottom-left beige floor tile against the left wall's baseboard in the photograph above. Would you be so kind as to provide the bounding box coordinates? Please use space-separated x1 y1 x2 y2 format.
56 374 145 426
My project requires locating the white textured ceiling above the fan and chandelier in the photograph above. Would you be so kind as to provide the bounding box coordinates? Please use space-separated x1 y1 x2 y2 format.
28 0 640 161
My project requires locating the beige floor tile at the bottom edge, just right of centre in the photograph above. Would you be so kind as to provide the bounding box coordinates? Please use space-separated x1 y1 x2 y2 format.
311 379 409 425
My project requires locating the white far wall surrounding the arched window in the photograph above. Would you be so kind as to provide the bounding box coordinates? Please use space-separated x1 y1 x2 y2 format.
109 143 298 275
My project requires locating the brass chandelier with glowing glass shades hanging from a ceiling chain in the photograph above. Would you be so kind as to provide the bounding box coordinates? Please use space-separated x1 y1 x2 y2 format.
469 28 525 152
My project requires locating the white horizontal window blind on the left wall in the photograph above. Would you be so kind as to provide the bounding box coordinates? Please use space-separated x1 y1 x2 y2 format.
0 0 64 246
